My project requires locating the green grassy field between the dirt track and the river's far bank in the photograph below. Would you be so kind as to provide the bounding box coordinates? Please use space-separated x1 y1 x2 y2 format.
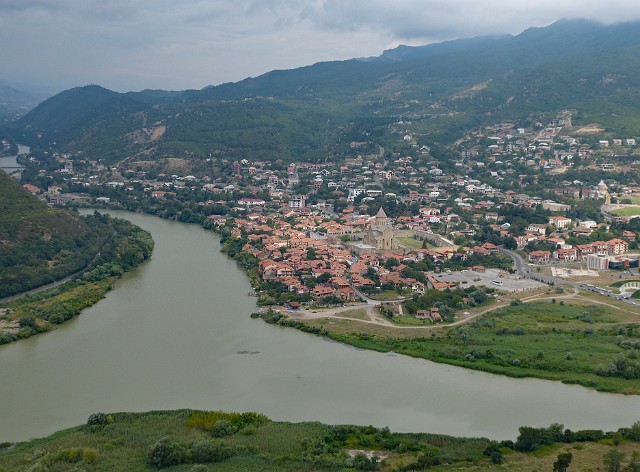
296 294 640 394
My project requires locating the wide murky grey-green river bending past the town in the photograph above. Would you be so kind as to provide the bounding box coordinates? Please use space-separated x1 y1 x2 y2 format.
0 212 640 442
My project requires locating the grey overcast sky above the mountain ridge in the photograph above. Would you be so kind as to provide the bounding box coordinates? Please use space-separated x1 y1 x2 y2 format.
0 0 640 92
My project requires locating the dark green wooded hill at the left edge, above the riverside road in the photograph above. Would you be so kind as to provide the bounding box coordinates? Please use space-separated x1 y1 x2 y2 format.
0 171 111 298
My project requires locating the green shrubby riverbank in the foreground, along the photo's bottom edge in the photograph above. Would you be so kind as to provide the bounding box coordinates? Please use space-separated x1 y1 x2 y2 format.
0 410 640 472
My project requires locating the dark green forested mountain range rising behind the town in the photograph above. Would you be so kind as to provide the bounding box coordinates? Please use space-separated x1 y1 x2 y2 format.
0 20 640 162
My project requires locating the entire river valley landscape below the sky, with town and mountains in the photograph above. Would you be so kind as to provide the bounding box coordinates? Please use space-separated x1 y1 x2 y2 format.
0 15 640 470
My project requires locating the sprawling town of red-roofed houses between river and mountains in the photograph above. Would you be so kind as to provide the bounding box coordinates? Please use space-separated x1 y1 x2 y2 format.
3 111 640 322
